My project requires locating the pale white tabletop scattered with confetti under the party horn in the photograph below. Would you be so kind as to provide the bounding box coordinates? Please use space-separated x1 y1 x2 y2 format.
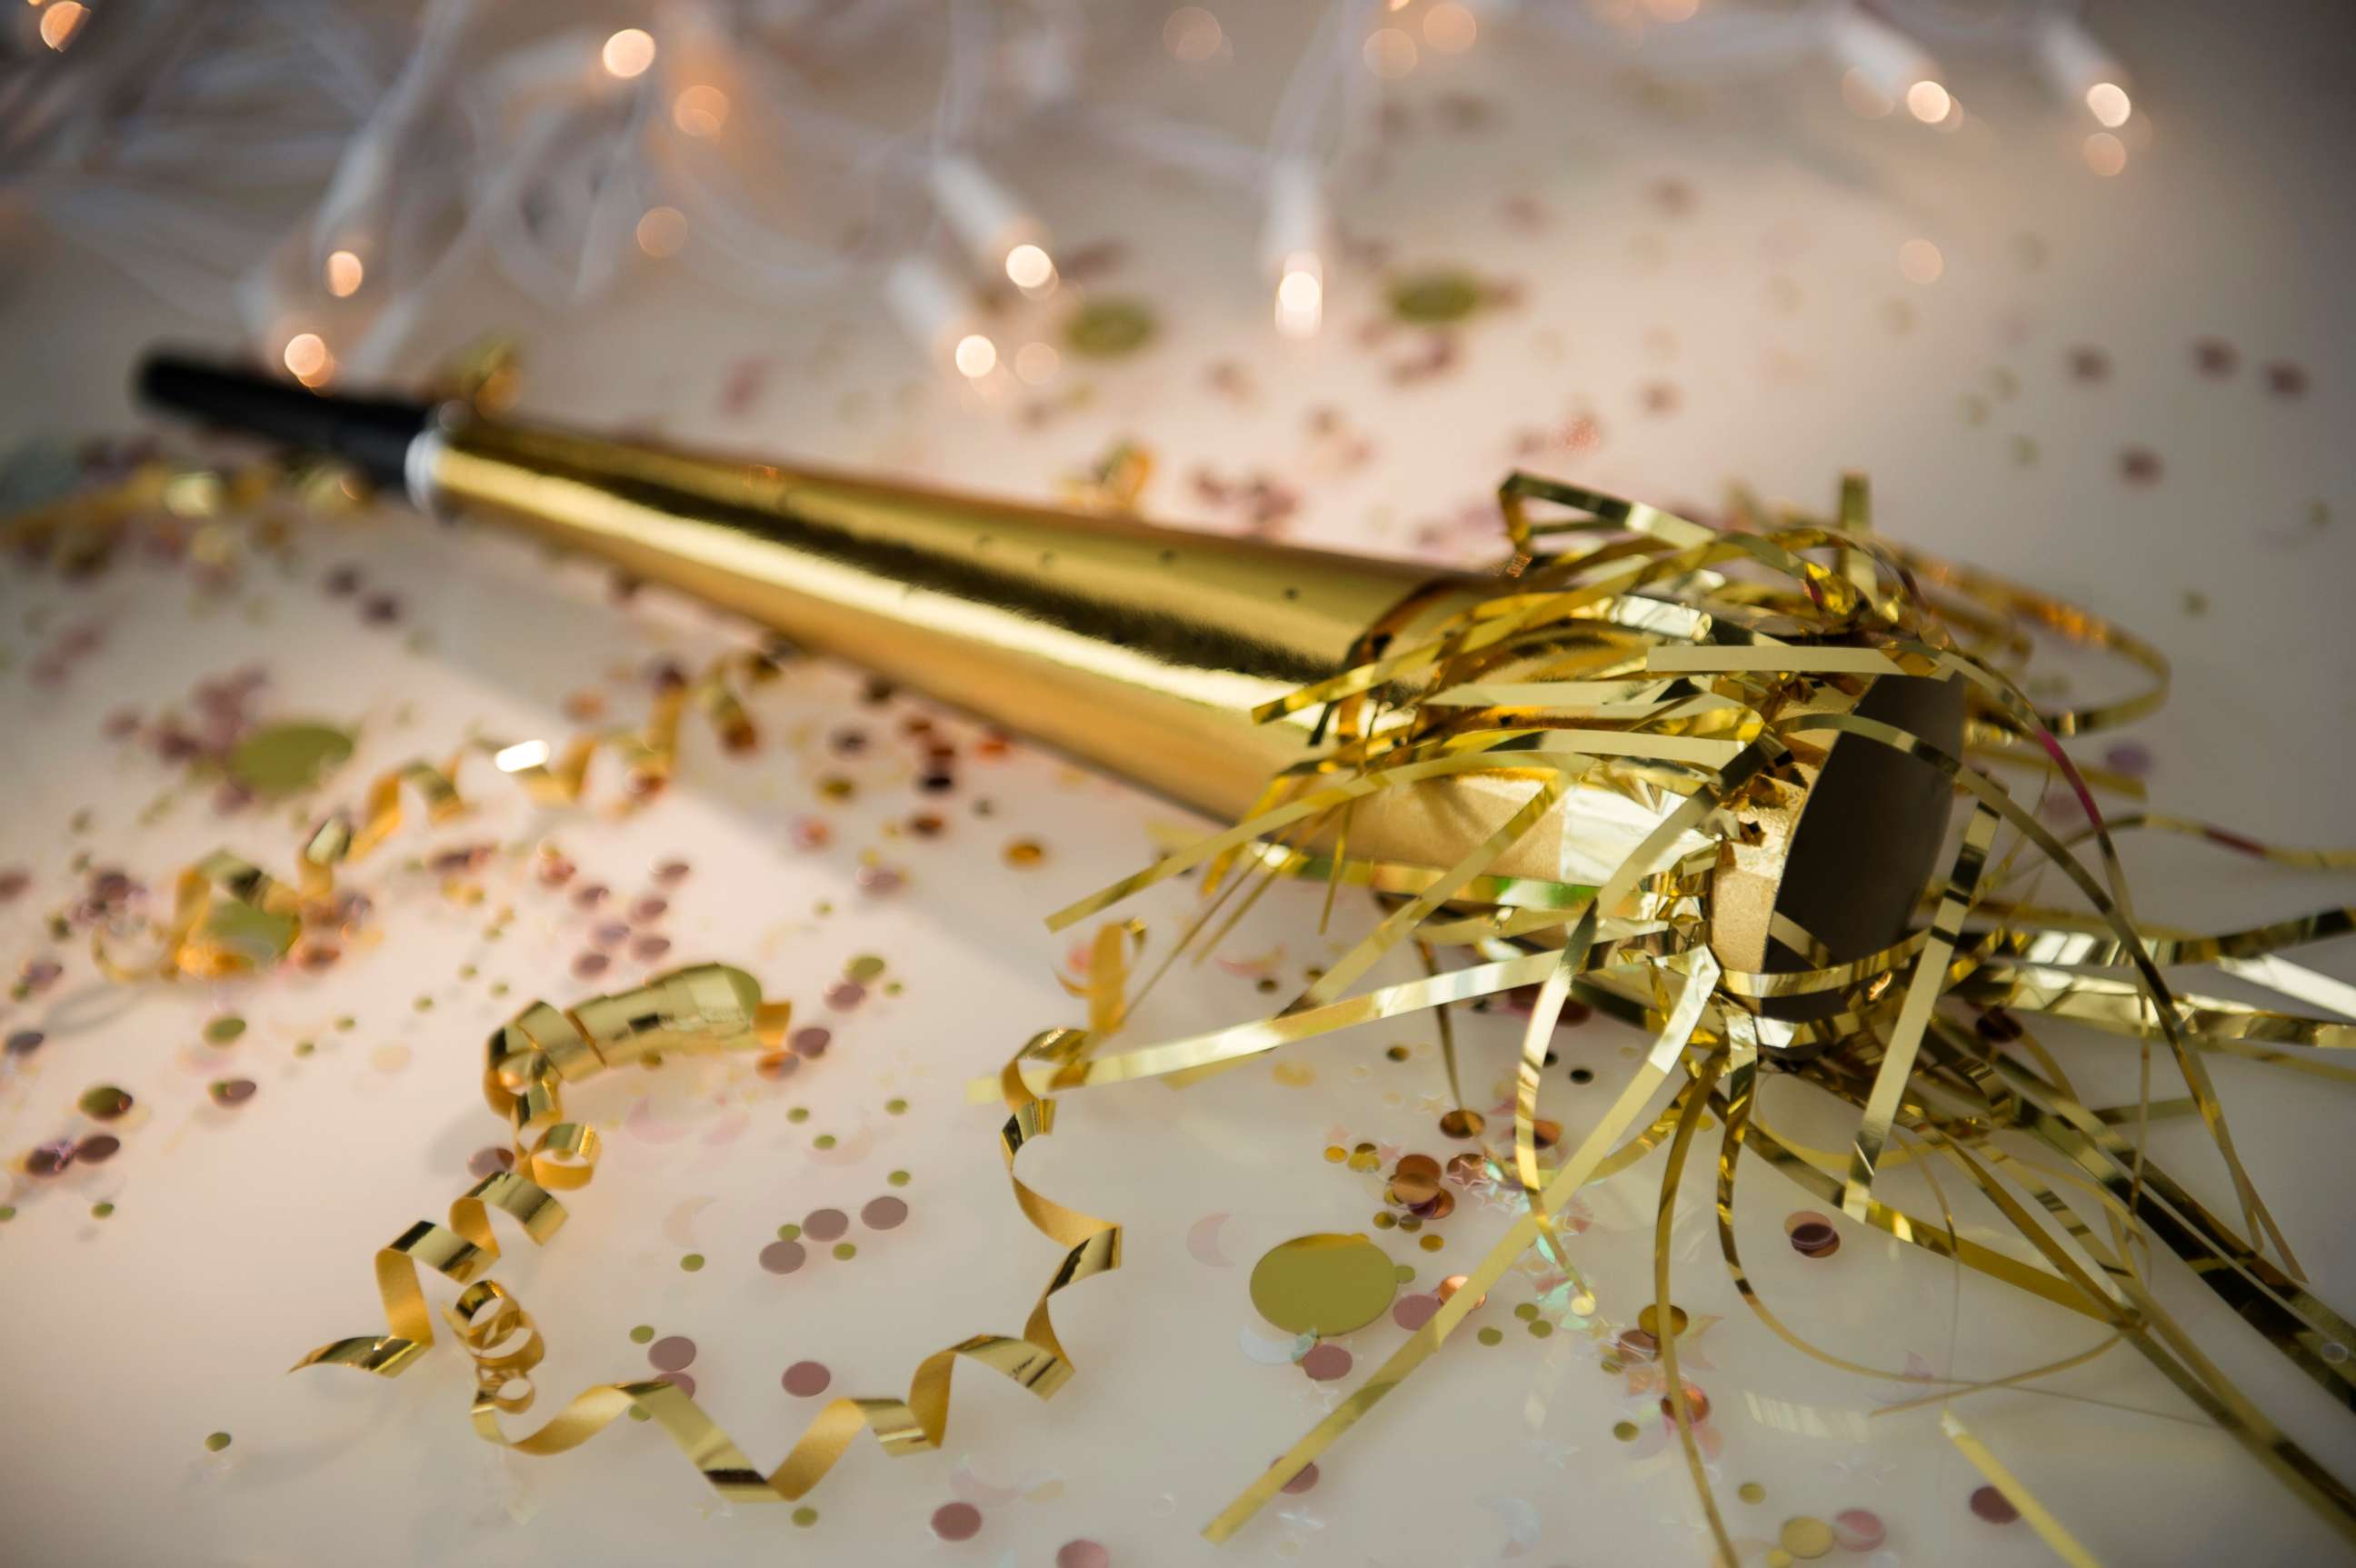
0 5 2356 1565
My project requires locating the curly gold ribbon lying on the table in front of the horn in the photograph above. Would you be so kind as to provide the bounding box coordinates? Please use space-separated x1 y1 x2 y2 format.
297 946 1138 1502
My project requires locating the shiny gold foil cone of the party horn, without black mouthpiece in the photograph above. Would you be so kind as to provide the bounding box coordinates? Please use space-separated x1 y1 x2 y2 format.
431 419 1696 883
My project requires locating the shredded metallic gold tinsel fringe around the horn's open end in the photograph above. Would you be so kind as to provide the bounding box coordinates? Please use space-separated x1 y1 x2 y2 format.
956 475 2356 1563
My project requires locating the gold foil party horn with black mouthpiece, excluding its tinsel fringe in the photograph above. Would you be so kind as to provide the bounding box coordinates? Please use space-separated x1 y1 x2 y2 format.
139 355 1962 979
